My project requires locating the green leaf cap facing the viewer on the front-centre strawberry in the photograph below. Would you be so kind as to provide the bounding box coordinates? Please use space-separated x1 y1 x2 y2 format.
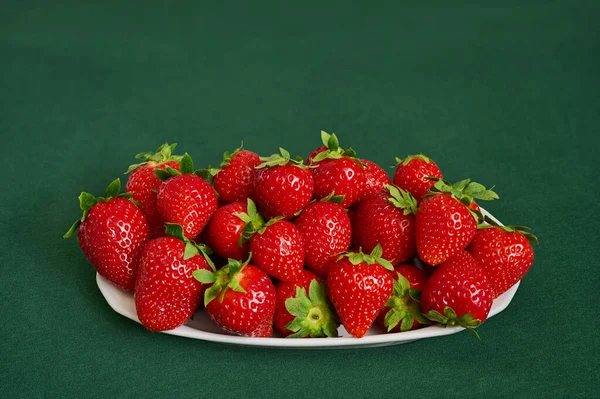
285 279 340 338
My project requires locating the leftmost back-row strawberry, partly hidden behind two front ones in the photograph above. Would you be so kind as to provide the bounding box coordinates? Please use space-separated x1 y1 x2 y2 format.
125 143 181 238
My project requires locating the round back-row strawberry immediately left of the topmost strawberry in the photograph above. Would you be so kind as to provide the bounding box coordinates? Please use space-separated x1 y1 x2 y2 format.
254 148 314 219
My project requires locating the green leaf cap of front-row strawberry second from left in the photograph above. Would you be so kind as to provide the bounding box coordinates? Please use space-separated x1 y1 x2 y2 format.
192 254 252 306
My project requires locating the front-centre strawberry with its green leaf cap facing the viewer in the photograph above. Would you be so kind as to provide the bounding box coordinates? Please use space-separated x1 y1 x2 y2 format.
273 270 340 338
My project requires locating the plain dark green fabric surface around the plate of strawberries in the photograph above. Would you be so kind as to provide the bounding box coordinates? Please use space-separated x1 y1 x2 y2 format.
0 0 600 398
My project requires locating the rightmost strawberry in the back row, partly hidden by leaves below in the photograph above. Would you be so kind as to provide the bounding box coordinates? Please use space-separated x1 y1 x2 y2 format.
392 154 443 201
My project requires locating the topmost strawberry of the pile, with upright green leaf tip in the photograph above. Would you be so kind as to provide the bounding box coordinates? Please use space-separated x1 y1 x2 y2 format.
310 131 366 208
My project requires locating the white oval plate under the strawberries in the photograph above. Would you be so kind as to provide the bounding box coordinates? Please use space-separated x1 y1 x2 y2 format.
96 208 520 349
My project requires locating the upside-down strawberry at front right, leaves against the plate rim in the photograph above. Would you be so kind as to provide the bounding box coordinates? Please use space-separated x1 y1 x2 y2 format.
421 250 493 338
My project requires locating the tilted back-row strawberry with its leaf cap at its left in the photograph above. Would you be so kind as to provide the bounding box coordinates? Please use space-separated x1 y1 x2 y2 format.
203 147 261 203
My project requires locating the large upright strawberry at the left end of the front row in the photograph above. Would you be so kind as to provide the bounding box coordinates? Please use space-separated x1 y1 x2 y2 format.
134 224 214 331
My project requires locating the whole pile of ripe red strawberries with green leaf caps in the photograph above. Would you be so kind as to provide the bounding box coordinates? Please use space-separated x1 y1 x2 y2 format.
65 132 537 338
